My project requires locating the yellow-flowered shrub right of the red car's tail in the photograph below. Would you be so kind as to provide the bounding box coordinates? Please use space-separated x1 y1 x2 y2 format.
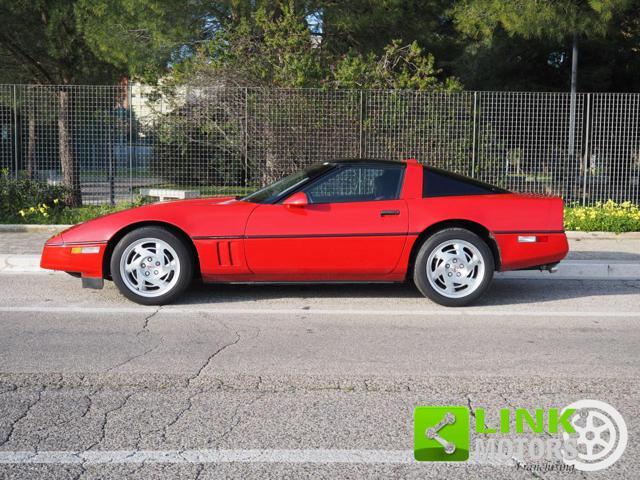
564 200 640 233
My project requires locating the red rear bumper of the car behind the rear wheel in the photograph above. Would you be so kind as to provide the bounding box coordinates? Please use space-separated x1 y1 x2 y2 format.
494 232 569 271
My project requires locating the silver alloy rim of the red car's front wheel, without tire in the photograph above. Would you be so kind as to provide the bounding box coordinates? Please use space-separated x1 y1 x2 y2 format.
120 238 180 297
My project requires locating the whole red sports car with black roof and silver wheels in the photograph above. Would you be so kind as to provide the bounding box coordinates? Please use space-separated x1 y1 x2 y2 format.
41 160 568 306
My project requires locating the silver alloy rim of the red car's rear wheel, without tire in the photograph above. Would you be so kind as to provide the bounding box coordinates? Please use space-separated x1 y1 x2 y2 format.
426 239 485 298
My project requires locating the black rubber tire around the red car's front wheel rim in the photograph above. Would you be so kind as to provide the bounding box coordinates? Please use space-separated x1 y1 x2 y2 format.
110 227 194 305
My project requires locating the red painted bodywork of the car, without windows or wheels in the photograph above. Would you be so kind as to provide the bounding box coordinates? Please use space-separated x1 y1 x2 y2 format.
41 160 568 282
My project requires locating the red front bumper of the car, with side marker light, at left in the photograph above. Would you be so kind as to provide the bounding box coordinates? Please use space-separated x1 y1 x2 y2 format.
40 242 107 278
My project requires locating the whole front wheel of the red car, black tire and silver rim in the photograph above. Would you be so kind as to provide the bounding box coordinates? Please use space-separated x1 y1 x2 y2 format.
111 227 193 305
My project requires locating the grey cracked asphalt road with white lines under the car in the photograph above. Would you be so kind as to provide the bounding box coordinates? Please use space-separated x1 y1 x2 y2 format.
0 274 640 479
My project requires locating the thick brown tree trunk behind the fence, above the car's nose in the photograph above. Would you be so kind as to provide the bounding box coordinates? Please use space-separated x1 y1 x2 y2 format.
58 88 82 207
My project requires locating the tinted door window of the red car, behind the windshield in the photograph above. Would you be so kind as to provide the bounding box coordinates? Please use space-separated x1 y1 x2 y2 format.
304 165 403 203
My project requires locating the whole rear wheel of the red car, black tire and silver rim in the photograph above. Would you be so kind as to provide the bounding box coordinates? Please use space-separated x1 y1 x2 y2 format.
413 228 495 307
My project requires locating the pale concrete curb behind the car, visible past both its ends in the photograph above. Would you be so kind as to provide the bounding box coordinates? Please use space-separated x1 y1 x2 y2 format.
0 254 640 280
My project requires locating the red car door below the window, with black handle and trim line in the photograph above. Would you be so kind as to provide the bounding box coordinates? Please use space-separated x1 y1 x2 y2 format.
245 200 408 278
